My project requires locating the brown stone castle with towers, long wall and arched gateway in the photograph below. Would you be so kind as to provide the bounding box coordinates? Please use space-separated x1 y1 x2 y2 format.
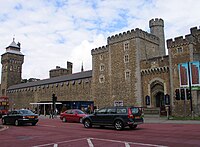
1 18 200 115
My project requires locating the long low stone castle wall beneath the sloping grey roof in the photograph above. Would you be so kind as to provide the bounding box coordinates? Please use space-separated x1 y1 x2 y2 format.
8 78 93 108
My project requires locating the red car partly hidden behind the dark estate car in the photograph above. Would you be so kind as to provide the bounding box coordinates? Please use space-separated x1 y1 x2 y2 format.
60 109 87 123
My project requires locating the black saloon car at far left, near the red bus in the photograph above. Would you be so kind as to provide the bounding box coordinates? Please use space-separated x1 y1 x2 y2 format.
2 109 38 126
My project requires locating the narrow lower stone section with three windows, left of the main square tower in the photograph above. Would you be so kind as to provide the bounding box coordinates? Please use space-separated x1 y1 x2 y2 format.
92 46 112 107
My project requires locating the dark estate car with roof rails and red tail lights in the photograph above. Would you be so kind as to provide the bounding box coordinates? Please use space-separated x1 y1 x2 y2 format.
82 106 144 130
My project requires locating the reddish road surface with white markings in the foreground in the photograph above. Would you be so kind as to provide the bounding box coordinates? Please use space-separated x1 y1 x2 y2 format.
0 118 200 147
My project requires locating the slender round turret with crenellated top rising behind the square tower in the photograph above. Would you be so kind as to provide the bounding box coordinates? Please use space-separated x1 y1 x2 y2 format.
149 18 166 56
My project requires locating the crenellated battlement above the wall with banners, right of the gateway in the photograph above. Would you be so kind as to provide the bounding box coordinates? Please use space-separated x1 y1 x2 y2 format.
167 34 194 48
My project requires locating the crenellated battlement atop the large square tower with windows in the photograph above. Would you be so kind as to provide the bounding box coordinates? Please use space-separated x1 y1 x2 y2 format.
107 28 159 45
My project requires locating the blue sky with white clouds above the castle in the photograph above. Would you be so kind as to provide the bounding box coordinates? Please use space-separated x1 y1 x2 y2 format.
0 0 200 79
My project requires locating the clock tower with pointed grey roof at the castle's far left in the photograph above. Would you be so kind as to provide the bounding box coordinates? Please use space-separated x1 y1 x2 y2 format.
1 38 24 96
